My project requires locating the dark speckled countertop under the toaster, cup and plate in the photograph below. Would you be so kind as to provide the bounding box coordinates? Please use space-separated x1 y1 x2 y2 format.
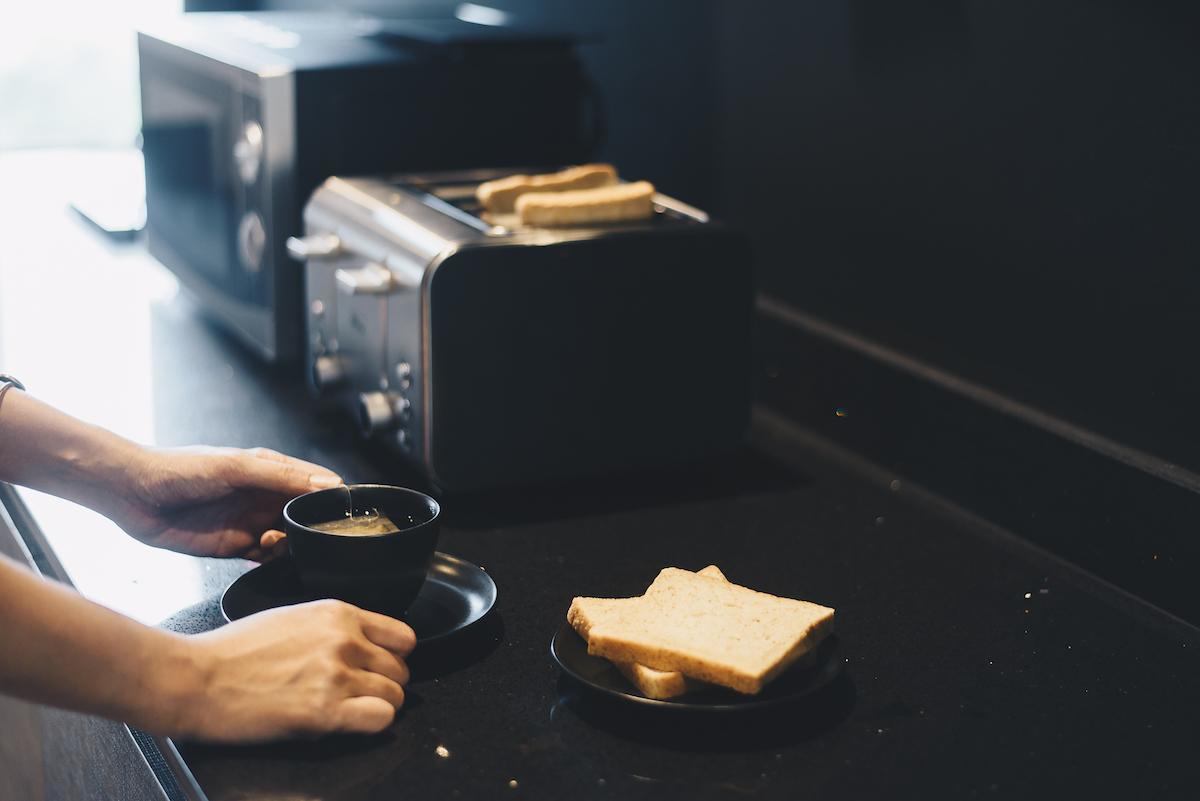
0 155 1200 801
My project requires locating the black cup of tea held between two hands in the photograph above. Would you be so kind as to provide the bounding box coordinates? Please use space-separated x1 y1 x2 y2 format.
283 484 442 618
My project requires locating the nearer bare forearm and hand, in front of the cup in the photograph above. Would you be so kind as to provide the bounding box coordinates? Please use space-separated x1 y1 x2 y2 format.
0 556 415 742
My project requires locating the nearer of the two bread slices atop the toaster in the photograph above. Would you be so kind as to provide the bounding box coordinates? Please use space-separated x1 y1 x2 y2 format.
516 181 654 228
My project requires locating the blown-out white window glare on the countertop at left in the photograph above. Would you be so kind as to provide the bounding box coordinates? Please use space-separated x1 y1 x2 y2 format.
0 151 226 622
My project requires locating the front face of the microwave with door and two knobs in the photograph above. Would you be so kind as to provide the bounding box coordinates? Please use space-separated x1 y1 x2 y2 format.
139 35 274 350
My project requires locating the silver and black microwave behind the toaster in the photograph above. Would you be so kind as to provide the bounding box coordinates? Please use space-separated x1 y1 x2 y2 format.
138 12 599 361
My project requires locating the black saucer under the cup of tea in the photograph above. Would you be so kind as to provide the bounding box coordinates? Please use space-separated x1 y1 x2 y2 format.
221 552 496 643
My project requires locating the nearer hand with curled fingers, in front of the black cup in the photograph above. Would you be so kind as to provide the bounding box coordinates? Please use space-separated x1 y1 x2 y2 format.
166 601 416 742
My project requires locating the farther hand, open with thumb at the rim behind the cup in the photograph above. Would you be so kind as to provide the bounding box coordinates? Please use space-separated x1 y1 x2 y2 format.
109 447 342 561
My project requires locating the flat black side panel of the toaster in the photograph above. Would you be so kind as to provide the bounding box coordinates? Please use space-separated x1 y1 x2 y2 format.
425 235 752 490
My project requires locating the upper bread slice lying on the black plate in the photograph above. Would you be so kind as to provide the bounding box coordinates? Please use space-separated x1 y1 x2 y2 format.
587 567 834 694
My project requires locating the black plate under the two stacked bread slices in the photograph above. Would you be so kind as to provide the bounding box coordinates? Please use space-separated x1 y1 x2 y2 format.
550 622 846 712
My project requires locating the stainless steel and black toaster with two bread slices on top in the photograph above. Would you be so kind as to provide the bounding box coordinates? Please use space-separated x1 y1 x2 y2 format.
288 170 754 492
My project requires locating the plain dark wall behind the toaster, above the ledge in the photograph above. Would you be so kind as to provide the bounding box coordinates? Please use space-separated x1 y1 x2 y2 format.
196 0 1200 469
